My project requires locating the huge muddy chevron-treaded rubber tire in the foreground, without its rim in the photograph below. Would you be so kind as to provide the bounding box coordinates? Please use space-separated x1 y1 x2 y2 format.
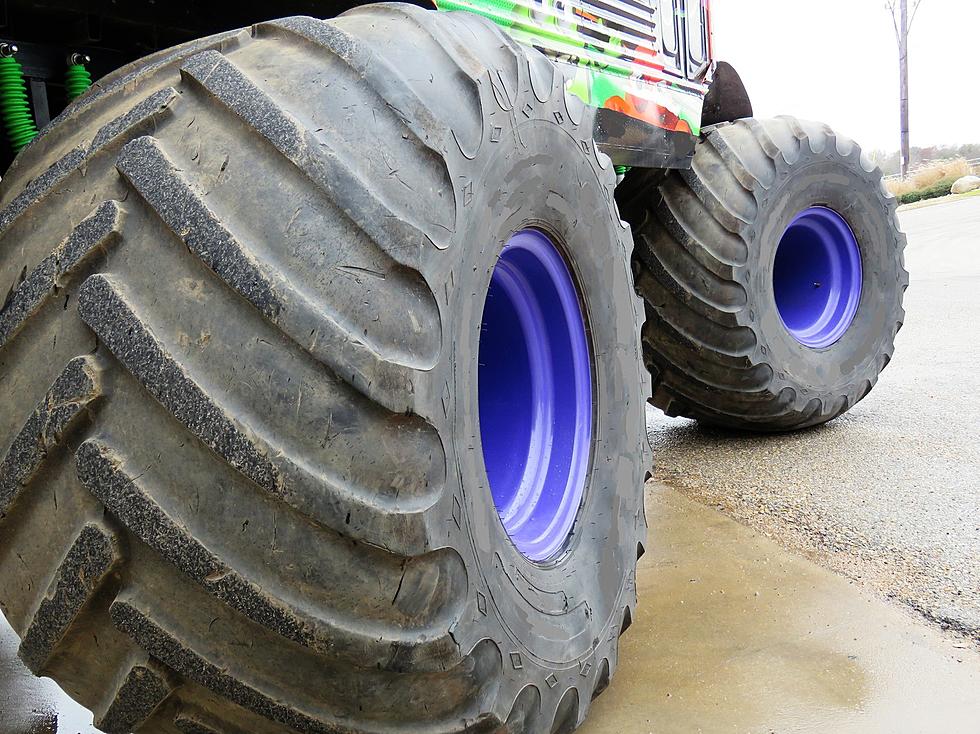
0 5 650 734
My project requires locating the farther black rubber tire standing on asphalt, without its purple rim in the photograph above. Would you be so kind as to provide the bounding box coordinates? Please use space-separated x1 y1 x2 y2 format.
617 117 908 431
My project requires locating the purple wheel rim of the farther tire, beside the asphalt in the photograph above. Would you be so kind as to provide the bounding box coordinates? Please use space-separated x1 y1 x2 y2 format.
772 206 862 349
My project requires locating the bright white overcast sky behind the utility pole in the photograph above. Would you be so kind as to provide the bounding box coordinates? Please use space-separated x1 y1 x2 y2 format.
711 0 980 150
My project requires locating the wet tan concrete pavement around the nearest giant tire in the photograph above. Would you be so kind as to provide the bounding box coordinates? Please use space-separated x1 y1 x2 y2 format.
0 483 980 734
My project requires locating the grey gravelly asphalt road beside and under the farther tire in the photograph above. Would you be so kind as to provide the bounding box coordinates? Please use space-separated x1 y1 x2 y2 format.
648 197 980 644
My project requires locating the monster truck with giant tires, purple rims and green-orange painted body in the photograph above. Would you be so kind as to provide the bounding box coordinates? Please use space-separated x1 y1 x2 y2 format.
0 0 907 734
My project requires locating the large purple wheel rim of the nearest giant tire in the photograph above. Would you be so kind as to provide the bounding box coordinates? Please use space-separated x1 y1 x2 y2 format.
478 229 592 562
